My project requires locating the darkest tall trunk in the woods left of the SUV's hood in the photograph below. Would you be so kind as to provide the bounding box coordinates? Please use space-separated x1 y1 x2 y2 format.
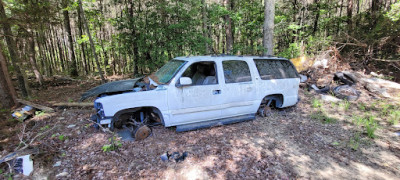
62 0 78 77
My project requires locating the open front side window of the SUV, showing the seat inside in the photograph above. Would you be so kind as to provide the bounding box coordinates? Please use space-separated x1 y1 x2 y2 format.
182 61 218 86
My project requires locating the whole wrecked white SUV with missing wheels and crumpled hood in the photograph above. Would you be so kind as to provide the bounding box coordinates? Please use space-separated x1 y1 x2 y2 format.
82 56 300 138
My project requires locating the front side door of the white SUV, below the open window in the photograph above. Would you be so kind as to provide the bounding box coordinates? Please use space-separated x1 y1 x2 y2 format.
166 61 223 126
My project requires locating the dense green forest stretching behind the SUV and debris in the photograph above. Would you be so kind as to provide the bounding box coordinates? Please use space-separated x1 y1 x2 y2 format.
0 0 400 106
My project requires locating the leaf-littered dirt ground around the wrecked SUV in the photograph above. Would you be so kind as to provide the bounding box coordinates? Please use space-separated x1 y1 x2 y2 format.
0 76 400 179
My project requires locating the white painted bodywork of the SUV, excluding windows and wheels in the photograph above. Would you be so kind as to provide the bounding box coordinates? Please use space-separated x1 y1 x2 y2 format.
95 56 300 127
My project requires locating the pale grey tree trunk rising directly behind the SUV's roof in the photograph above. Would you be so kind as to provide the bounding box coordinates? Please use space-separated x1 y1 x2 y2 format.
263 0 275 55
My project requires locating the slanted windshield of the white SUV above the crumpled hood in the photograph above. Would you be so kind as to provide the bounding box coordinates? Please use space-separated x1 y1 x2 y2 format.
150 59 186 84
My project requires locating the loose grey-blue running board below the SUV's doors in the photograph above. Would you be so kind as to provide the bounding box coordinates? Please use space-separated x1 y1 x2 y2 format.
176 114 256 132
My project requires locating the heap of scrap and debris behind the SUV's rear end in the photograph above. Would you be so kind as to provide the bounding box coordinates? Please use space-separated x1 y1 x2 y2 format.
292 48 400 102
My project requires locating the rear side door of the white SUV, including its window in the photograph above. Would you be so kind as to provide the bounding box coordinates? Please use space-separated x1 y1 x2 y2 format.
221 60 258 117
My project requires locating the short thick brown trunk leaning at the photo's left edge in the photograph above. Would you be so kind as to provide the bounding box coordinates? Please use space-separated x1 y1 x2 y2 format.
0 43 18 109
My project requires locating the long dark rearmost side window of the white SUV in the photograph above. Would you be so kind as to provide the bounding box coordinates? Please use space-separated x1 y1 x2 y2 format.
254 59 297 80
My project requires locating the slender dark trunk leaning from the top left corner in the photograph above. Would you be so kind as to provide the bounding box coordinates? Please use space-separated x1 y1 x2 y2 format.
0 0 29 97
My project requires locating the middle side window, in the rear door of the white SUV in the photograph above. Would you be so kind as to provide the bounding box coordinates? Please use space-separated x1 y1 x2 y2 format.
222 61 251 83
